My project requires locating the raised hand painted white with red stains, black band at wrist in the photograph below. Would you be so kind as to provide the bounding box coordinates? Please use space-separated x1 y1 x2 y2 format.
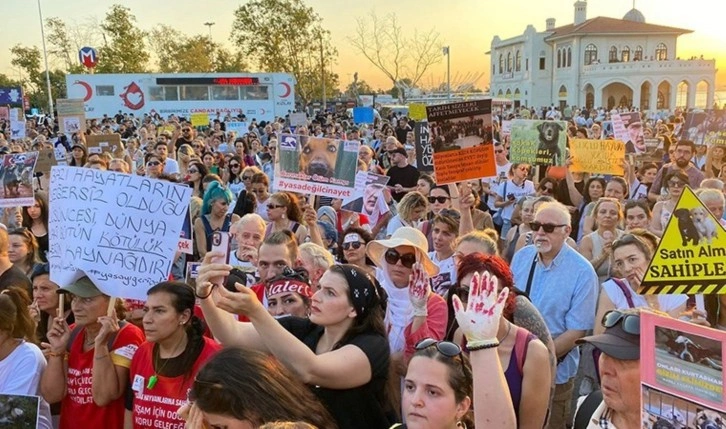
452 272 509 348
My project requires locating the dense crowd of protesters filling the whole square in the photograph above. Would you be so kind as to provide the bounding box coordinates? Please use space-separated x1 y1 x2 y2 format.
0 102 726 429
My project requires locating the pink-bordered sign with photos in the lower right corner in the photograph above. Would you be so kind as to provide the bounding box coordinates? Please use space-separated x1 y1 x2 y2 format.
640 311 726 422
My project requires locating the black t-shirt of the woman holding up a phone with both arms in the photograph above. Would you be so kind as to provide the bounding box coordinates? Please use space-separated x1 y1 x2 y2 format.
279 317 391 429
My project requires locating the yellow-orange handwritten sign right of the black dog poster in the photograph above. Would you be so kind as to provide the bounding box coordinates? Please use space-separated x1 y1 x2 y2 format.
570 139 625 176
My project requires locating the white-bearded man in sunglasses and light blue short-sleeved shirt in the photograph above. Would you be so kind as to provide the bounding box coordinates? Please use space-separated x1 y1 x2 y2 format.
511 202 599 429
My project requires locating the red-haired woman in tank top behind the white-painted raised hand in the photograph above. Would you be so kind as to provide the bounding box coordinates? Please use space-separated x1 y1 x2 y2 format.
446 252 552 429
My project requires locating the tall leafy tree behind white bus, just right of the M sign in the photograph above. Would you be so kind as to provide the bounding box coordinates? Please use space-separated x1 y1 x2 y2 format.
96 4 149 73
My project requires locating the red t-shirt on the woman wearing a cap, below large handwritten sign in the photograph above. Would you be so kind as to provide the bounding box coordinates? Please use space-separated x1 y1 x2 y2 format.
60 323 144 429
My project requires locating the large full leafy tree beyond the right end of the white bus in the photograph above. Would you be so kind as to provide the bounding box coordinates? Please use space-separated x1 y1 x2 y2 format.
230 0 338 104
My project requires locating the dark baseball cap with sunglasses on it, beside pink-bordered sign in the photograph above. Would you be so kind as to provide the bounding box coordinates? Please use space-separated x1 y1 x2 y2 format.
576 310 640 360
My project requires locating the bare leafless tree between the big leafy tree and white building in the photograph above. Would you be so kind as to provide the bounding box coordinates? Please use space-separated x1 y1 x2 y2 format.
348 12 442 98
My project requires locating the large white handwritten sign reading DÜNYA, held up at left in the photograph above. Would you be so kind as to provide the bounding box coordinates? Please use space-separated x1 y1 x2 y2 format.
48 166 192 300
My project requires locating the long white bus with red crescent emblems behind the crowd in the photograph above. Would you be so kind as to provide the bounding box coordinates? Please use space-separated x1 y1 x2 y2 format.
66 73 295 121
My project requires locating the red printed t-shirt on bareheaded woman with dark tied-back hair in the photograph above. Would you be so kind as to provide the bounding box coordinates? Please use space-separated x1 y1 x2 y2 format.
129 337 222 429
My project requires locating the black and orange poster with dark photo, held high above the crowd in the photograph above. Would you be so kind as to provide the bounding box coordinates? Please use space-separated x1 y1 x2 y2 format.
426 99 497 185
